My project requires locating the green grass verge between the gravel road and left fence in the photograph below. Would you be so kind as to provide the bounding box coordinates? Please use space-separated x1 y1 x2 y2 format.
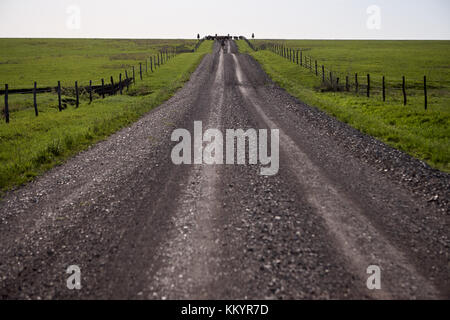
0 41 212 190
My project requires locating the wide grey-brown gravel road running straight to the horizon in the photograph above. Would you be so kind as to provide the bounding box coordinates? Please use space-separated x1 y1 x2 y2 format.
0 42 450 299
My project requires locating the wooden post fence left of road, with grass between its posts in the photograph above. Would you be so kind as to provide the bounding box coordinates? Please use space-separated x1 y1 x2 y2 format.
0 47 182 123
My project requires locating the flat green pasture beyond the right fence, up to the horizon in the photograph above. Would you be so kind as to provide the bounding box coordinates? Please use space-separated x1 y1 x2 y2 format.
254 40 450 89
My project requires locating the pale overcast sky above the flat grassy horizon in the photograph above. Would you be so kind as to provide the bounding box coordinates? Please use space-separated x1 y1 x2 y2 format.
0 0 450 39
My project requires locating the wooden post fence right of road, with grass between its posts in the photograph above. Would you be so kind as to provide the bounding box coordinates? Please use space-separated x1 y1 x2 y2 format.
261 44 440 110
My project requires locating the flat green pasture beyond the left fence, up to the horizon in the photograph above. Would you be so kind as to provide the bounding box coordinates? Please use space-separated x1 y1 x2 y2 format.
0 39 196 89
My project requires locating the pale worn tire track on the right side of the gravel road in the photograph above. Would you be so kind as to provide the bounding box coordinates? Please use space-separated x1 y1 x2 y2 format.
233 48 440 299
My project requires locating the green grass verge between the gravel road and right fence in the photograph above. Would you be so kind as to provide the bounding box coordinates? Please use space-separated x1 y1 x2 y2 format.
238 41 450 172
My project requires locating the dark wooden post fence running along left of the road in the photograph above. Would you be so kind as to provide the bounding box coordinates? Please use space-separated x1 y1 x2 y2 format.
0 46 182 123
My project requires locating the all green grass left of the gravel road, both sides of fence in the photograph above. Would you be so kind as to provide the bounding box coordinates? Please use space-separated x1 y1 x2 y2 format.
0 40 212 190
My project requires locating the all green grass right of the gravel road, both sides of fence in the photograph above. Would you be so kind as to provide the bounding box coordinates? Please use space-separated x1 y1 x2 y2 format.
238 40 450 172
